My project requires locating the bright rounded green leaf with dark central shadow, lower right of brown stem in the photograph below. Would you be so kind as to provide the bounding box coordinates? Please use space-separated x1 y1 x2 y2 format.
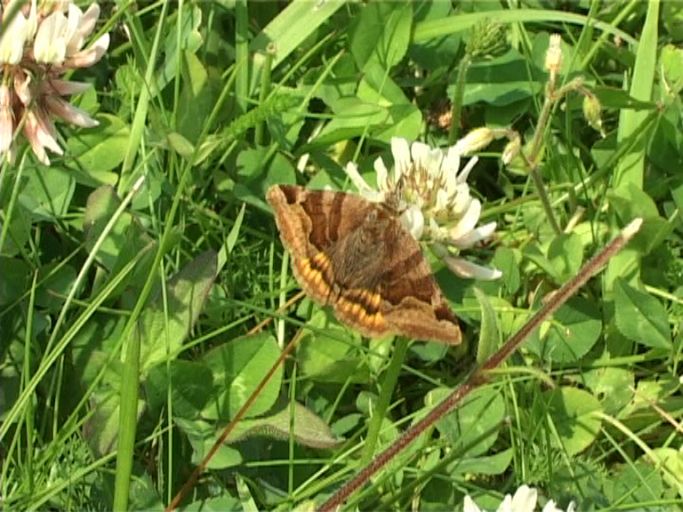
545 387 602 456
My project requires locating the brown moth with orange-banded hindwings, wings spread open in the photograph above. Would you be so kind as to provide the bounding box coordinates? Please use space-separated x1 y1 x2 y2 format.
267 185 461 345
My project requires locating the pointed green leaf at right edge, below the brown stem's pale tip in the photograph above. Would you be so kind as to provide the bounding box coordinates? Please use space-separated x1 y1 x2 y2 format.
614 279 671 349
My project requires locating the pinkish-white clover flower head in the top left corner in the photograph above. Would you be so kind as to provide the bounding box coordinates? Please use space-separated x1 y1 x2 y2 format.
0 0 109 165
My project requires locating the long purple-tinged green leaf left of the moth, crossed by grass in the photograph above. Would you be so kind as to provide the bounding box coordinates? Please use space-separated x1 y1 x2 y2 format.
137 251 216 372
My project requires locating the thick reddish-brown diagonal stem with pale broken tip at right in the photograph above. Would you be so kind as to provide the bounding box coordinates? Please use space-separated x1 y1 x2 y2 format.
318 219 642 512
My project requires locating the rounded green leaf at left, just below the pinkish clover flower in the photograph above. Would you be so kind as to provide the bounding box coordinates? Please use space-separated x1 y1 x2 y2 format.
18 166 76 220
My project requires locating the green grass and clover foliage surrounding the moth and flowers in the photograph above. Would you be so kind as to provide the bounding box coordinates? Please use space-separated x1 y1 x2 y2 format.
0 0 683 510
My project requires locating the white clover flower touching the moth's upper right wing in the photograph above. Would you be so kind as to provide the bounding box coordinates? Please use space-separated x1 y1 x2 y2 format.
346 133 501 280
